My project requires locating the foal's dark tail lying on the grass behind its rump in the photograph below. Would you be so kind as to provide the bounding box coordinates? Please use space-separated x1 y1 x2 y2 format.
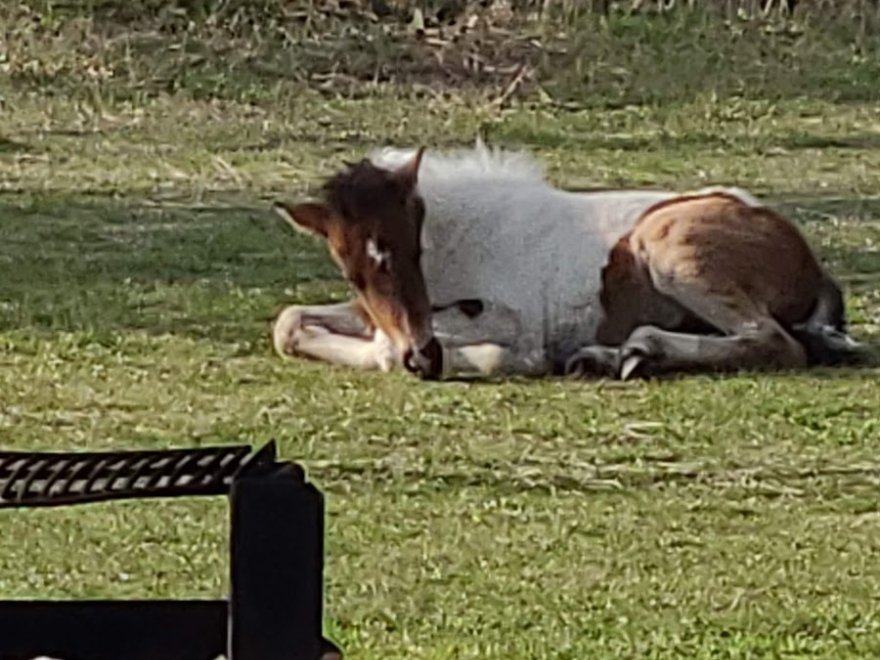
790 275 878 366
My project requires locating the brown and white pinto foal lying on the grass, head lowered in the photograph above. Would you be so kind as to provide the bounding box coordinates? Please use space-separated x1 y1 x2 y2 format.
273 145 859 378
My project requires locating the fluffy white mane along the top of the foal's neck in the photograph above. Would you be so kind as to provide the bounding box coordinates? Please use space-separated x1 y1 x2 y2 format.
369 140 546 183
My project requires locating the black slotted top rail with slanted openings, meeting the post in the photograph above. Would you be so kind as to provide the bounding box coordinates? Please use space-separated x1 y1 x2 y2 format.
0 441 275 509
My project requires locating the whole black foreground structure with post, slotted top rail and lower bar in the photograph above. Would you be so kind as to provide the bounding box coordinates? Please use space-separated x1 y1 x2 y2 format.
0 442 341 660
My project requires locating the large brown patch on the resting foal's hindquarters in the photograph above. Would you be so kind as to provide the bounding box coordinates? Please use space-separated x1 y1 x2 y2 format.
597 193 825 366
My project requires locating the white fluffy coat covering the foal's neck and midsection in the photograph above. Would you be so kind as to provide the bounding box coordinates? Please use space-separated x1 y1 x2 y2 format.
368 143 761 371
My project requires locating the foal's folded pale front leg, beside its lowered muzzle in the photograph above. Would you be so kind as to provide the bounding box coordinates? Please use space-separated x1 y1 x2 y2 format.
272 301 398 371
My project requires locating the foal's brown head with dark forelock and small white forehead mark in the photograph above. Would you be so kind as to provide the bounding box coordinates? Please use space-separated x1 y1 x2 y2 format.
275 149 443 378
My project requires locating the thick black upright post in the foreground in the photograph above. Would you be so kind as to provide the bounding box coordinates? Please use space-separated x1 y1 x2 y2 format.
228 468 325 660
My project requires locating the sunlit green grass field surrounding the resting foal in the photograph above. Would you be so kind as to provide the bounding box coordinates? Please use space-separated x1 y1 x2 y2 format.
0 2 880 660
